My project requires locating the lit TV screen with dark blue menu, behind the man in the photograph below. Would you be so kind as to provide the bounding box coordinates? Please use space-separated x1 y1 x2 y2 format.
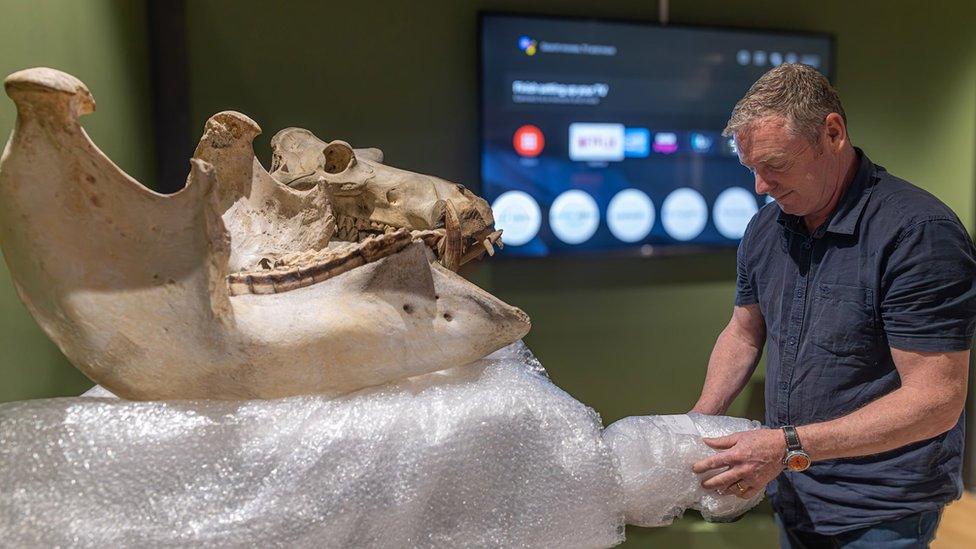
480 14 831 256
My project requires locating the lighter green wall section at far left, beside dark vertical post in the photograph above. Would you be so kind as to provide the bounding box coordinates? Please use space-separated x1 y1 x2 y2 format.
0 0 153 402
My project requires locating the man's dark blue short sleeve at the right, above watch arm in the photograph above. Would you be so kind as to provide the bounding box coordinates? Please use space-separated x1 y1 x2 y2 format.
880 219 976 352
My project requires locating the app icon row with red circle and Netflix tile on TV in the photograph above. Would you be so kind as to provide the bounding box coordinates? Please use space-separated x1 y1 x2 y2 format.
512 122 737 162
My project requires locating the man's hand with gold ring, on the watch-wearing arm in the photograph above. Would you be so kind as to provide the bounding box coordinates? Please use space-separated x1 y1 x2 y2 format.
692 429 786 499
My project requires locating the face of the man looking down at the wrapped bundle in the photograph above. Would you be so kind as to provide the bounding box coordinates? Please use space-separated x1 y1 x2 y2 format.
735 116 836 216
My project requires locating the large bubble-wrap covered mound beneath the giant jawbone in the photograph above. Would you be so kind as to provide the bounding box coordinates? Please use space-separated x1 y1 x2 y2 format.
0 344 623 547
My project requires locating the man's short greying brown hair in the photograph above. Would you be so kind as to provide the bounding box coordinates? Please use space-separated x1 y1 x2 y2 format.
722 63 847 143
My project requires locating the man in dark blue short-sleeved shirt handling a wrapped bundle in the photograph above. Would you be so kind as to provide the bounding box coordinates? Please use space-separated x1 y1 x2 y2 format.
693 64 976 547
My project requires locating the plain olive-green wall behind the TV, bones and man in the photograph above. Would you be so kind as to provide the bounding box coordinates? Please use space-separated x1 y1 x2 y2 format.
0 0 976 547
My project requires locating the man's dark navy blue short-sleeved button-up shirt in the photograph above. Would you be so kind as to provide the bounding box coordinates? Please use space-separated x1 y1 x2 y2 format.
735 150 976 535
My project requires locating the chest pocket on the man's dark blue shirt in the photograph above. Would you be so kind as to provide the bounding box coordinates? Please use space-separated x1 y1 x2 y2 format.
808 284 879 358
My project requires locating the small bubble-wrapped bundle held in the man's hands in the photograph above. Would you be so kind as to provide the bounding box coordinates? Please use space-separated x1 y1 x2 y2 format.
603 413 763 526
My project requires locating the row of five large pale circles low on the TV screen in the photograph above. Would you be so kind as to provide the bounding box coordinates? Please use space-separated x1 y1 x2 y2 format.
491 187 759 246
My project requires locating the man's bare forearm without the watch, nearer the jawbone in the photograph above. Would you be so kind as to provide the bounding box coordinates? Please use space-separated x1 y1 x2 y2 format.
692 325 762 415
